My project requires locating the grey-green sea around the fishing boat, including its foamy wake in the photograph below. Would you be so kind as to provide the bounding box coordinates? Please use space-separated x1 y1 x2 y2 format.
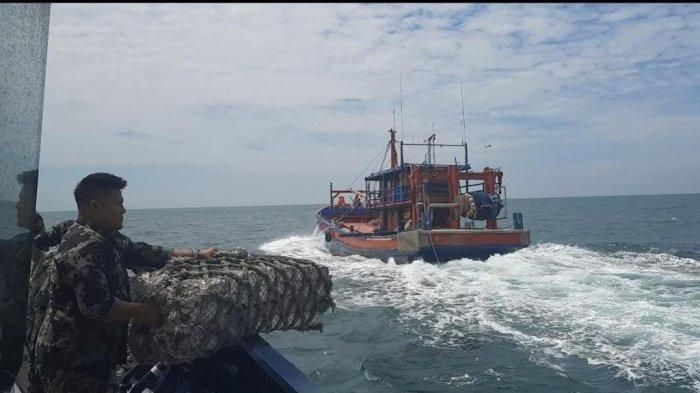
42 194 700 393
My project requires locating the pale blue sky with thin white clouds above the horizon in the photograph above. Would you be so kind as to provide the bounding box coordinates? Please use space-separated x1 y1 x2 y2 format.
37 4 700 211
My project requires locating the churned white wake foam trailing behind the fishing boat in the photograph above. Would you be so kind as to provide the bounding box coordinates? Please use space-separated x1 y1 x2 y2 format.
261 236 700 392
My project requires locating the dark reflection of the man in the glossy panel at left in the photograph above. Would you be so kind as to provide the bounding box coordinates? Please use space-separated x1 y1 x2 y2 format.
0 170 43 391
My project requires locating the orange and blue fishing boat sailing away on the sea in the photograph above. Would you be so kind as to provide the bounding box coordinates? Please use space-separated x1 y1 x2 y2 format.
316 128 530 263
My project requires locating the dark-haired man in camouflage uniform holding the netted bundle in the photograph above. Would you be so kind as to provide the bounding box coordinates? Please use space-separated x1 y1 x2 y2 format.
29 173 216 393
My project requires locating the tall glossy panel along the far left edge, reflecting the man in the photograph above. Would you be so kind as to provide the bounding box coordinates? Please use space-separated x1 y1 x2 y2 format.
0 3 51 392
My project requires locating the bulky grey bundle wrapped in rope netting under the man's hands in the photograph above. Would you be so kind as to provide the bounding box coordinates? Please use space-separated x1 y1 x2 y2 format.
129 251 335 363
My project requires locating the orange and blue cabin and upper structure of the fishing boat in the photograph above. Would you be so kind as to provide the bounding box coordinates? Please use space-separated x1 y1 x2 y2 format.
319 129 506 235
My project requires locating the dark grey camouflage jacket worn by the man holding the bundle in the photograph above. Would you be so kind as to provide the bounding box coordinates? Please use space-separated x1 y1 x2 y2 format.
35 222 171 377
